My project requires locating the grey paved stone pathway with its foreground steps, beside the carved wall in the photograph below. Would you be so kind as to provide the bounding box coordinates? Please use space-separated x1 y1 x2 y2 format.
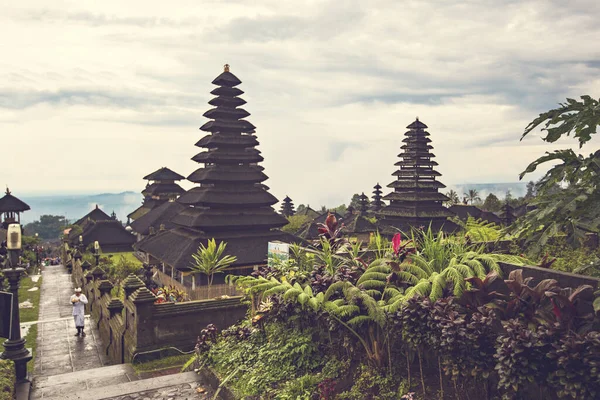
29 265 213 400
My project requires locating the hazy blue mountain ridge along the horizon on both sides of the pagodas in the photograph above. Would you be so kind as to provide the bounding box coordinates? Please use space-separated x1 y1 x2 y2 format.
20 182 527 223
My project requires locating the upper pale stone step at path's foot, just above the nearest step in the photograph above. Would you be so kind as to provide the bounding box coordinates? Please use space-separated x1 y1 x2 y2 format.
32 364 138 399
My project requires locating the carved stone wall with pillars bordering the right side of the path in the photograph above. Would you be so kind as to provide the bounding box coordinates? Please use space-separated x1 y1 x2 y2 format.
72 262 247 363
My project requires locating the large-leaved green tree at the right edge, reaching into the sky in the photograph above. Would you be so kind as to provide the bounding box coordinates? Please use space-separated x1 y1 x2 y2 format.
515 96 600 252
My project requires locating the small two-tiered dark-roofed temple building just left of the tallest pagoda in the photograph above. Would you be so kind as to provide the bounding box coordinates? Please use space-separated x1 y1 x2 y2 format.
127 167 185 225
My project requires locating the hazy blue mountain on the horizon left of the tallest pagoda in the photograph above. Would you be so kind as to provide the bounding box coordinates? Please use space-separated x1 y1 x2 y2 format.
20 192 143 224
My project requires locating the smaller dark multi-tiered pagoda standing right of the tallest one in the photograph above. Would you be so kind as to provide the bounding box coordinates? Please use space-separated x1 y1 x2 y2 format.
379 118 457 231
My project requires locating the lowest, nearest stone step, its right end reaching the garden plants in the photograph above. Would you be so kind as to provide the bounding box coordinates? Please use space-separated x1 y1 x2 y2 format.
43 370 198 400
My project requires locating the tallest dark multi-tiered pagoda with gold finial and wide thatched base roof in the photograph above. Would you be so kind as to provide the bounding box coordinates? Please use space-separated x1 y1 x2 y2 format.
135 65 297 286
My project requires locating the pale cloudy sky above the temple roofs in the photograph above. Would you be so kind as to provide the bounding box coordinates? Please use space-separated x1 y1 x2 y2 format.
0 0 600 205
